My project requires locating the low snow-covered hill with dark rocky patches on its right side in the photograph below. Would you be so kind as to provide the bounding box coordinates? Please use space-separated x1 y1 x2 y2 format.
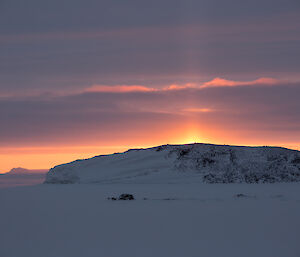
45 144 300 183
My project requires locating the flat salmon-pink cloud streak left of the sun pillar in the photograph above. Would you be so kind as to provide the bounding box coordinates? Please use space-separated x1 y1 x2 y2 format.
85 85 157 93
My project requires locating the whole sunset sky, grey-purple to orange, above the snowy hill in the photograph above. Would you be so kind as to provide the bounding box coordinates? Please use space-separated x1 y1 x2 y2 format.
0 0 300 172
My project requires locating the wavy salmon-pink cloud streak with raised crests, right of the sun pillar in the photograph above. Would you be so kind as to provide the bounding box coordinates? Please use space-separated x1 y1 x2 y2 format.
200 78 282 88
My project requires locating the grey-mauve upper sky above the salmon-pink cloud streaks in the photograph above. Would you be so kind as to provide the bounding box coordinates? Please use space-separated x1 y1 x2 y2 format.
0 0 300 93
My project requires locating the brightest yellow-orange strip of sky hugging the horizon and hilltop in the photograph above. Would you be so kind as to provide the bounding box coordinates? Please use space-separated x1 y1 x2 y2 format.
0 134 300 173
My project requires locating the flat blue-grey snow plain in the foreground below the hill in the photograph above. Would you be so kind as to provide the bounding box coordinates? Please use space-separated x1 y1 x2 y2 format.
0 183 300 257
